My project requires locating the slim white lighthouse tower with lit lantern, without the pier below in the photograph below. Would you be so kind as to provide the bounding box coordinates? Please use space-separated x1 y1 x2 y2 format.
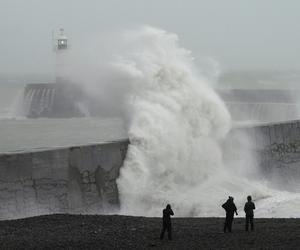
54 28 68 83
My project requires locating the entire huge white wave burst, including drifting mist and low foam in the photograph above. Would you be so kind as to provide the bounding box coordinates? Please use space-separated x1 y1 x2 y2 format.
63 24 300 217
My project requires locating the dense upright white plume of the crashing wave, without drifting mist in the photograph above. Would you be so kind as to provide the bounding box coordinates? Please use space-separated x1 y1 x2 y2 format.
113 27 258 216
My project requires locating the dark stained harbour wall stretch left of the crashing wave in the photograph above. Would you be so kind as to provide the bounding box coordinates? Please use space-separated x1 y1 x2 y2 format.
0 140 128 219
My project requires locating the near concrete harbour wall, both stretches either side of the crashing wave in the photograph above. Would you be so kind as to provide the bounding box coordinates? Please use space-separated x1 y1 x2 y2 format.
0 121 300 219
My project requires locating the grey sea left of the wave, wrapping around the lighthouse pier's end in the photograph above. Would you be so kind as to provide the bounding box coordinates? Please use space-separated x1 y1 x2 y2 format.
0 79 127 153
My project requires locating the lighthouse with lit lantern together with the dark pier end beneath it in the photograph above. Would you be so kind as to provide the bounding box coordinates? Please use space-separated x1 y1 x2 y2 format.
22 29 85 118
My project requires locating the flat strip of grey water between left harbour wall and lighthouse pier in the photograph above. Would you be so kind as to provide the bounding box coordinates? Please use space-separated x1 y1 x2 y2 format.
0 118 127 153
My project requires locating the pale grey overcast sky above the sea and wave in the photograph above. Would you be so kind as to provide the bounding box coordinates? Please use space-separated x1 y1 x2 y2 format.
0 0 300 73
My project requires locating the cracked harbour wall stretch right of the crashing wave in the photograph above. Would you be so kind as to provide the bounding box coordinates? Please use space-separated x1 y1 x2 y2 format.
228 121 300 192
